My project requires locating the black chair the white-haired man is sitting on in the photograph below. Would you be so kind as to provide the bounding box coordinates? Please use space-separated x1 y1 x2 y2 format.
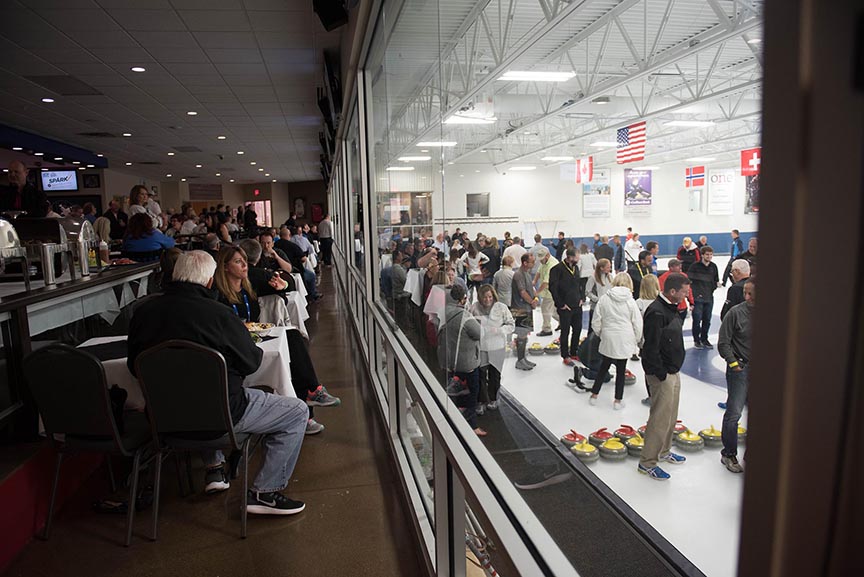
135 340 252 541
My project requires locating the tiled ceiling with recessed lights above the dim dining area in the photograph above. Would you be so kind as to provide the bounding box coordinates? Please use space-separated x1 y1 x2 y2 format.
0 0 340 182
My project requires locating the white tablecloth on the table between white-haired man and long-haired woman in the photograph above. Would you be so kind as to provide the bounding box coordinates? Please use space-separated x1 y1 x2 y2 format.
80 327 297 411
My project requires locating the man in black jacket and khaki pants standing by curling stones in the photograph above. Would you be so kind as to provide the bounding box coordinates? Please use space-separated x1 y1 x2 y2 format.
638 273 690 481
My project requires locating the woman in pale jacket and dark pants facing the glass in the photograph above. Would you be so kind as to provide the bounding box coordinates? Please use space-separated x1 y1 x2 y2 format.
471 284 516 415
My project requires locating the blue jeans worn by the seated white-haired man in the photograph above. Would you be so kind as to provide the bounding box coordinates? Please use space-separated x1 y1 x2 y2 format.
202 389 309 493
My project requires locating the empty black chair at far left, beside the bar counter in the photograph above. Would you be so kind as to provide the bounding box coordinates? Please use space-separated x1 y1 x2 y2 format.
24 343 152 547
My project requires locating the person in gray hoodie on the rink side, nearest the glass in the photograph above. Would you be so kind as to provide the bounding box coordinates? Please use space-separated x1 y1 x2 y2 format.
438 285 486 437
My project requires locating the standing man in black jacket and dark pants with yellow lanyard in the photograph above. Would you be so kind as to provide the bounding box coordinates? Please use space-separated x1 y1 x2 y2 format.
549 248 585 367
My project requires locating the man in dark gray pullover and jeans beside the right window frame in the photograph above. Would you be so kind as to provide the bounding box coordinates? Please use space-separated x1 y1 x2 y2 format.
717 279 756 473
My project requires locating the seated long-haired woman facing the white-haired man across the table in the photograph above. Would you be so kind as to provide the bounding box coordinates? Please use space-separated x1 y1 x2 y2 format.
213 241 341 435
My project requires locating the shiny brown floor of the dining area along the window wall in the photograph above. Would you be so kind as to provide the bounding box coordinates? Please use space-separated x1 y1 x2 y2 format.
1 270 424 577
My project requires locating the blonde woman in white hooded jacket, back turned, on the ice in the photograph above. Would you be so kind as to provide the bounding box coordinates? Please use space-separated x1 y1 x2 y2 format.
588 272 642 411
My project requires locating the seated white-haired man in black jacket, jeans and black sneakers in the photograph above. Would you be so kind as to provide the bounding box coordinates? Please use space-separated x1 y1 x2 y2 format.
127 251 309 515
